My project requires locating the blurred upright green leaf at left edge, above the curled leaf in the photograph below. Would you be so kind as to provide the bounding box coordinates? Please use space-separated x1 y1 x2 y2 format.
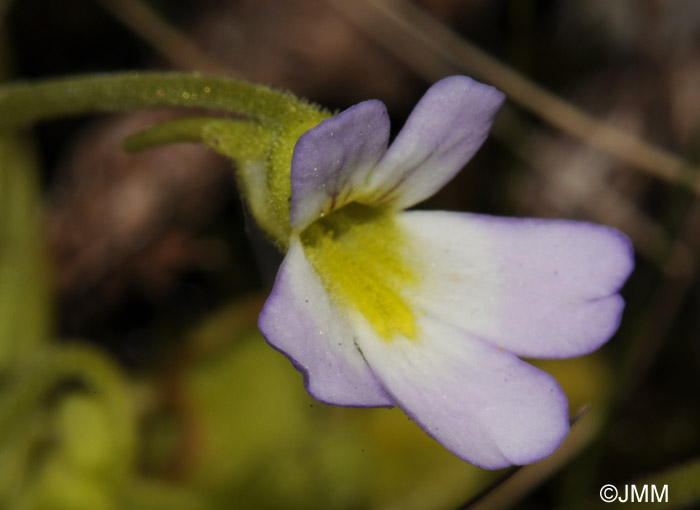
0 134 49 374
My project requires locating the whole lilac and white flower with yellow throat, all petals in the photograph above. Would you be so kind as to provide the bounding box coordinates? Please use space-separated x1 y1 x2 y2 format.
258 76 633 469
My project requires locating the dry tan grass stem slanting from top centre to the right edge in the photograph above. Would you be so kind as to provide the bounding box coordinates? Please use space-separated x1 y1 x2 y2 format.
326 0 700 194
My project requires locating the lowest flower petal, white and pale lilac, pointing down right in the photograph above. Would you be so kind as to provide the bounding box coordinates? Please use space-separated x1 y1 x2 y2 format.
357 315 569 469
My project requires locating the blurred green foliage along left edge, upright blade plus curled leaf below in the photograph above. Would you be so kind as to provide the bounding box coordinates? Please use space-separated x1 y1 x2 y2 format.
0 48 135 510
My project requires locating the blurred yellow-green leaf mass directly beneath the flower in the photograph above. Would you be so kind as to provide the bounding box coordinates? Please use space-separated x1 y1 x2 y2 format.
147 302 493 510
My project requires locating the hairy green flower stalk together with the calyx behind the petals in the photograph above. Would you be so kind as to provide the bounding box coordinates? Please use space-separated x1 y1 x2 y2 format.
0 72 330 247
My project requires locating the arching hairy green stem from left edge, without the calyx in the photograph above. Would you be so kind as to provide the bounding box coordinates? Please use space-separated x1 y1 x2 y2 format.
0 72 320 129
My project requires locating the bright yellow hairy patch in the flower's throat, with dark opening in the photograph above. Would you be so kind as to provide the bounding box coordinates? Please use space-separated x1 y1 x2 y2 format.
301 203 418 342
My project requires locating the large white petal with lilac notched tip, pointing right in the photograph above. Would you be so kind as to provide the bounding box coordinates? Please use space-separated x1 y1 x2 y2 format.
399 211 634 358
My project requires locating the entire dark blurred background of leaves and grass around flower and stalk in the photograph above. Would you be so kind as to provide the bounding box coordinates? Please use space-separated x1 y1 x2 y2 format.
0 0 700 510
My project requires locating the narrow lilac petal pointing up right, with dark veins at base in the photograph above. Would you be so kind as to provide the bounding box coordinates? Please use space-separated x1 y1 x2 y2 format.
366 76 505 209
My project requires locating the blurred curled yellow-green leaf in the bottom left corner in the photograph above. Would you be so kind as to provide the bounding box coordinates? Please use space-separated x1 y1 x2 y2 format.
0 344 136 510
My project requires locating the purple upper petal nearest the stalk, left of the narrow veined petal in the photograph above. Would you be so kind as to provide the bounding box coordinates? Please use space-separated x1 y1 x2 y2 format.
290 100 389 232
